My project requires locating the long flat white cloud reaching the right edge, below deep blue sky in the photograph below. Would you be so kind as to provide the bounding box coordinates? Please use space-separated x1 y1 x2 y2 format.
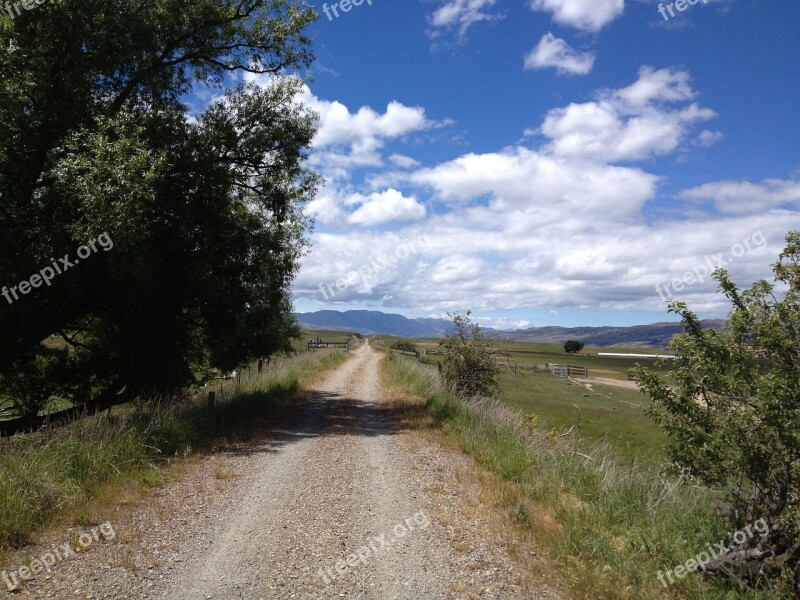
680 179 800 215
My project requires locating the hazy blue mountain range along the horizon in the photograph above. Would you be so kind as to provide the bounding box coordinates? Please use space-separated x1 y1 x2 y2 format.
297 310 723 348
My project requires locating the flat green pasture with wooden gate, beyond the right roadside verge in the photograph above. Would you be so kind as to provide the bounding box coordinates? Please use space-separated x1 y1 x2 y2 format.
380 336 668 467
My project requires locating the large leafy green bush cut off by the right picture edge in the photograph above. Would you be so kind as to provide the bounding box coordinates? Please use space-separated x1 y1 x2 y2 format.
637 232 800 597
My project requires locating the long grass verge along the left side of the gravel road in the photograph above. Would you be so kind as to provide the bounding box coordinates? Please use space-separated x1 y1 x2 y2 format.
0 350 345 552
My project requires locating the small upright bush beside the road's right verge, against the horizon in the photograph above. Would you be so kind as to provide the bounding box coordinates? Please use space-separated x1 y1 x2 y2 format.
439 311 498 396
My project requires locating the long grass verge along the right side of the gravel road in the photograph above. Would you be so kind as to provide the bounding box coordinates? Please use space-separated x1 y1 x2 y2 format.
384 355 774 600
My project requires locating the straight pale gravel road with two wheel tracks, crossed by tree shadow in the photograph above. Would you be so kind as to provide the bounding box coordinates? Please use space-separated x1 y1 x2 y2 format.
3 345 562 600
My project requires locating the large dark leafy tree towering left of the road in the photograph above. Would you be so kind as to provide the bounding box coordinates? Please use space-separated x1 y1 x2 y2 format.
0 0 317 432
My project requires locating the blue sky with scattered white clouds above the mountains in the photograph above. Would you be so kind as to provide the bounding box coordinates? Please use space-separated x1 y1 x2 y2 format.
242 0 800 329
